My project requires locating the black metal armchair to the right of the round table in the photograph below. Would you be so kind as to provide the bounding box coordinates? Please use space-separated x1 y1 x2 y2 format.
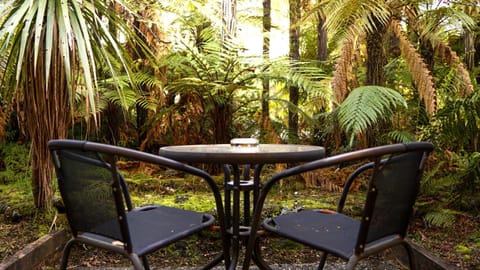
243 142 433 269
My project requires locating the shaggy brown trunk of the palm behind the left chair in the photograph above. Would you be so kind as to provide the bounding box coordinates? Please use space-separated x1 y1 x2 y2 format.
22 28 71 209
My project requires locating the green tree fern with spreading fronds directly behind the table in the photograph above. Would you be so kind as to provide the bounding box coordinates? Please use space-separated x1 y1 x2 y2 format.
160 15 330 141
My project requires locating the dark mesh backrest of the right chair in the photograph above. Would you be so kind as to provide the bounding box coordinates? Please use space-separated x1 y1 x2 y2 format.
356 144 431 254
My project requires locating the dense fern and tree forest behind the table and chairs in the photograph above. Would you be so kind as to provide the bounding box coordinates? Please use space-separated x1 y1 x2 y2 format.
0 0 480 269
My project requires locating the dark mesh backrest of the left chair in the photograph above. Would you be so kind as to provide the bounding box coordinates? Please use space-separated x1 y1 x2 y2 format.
51 145 131 246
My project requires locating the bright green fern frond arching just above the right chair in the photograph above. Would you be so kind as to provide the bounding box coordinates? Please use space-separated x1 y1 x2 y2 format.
338 86 407 144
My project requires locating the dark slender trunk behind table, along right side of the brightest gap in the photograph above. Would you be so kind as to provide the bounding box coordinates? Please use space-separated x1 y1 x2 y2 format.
288 0 300 143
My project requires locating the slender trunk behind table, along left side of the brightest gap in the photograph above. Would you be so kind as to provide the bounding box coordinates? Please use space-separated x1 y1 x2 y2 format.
261 0 272 141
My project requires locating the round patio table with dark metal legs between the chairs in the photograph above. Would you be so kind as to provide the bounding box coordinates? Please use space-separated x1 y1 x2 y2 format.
159 144 325 269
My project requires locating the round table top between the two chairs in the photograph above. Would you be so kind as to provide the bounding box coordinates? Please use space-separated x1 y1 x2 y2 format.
159 144 325 164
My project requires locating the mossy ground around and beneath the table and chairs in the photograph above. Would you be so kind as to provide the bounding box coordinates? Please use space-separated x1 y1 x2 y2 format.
0 160 480 269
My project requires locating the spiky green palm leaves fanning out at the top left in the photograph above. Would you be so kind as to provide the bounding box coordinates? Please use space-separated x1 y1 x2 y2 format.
0 0 141 124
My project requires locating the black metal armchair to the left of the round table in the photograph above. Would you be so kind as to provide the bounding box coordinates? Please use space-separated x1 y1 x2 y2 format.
48 140 226 269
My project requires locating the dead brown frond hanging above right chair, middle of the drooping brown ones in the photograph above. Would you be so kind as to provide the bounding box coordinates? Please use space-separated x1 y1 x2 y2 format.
390 20 437 116
